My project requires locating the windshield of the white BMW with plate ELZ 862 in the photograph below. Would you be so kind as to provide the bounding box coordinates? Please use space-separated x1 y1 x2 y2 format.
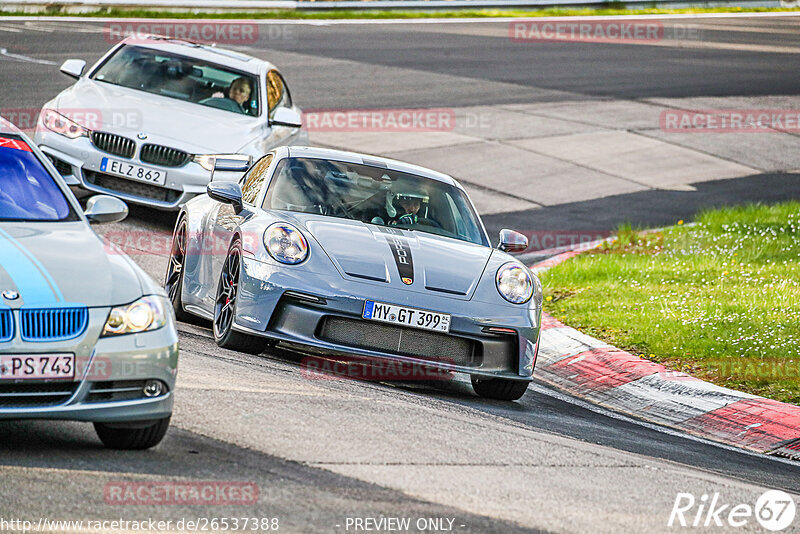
92 45 259 116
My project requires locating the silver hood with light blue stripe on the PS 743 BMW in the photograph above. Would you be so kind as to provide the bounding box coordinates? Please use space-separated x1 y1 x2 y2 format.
0 222 147 307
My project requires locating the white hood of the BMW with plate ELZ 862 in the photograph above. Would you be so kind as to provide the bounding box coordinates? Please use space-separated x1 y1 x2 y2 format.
55 78 263 154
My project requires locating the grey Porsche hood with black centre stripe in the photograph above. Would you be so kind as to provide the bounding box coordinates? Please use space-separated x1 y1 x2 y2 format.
295 214 492 300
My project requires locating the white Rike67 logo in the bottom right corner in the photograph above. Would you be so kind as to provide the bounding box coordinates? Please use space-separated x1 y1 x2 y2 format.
667 490 797 532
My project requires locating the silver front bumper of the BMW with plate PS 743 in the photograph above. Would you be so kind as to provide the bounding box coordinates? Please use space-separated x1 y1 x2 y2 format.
0 308 178 423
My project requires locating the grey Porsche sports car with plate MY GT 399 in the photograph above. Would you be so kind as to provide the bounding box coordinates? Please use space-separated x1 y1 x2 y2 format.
166 147 542 400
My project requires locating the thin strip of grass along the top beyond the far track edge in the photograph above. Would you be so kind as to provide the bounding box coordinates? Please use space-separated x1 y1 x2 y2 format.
0 6 800 20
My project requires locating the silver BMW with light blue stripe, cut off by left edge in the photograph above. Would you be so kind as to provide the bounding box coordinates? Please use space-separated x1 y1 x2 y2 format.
0 118 178 449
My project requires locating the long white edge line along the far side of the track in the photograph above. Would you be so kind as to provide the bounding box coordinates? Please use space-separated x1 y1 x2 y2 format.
0 10 800 26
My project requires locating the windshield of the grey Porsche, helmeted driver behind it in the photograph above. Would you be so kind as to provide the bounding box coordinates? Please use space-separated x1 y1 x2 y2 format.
264 158 488 246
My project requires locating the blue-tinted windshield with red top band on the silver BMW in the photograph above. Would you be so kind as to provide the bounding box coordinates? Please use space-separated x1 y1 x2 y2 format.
0 134 73 221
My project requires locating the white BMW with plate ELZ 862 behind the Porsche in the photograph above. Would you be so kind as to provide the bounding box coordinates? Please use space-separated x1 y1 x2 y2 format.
35 36 308 210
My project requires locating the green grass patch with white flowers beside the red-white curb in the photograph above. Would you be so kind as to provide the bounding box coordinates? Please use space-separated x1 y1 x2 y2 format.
542 202 800 404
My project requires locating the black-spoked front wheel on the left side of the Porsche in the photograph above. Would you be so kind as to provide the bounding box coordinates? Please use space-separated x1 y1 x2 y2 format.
212 239 270 354
